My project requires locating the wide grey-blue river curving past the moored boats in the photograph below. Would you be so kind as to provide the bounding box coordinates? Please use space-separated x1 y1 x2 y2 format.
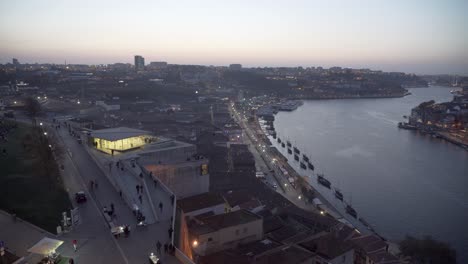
274 86 468 263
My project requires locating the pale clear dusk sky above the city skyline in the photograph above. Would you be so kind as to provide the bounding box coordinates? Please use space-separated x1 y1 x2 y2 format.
0 0 468 75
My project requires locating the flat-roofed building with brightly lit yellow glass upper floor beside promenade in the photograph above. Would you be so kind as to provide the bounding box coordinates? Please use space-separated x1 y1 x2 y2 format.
88 127 210 198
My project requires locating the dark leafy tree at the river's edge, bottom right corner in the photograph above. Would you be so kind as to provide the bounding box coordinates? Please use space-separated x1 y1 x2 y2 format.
400 236 457 264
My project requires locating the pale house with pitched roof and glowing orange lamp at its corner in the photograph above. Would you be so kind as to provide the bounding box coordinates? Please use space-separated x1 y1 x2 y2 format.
187 210 263 259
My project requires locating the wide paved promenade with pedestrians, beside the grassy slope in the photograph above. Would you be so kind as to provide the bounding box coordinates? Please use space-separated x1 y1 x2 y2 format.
38 120 179 263
